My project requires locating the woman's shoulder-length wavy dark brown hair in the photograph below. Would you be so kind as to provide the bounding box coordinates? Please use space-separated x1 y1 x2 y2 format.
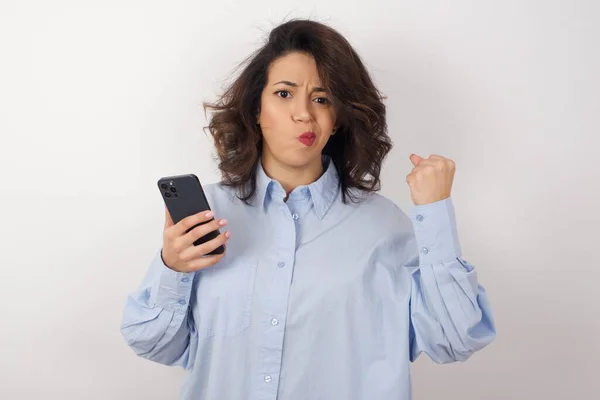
204 19 392 204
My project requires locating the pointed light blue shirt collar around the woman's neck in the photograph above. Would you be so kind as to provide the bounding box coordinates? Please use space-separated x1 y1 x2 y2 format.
256 155 340 219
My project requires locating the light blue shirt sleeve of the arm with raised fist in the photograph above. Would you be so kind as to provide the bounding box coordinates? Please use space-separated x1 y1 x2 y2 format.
409 197 496 363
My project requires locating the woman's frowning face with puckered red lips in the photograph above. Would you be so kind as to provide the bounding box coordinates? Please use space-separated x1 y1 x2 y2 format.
258 53 336 168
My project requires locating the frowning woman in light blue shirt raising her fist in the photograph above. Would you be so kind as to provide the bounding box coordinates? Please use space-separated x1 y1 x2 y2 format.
122 20 495 400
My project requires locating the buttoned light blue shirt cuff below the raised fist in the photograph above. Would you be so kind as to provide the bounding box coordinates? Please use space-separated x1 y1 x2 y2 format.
410 197 462 265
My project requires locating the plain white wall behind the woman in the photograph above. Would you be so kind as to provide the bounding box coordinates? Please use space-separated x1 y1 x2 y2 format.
0 0 600 400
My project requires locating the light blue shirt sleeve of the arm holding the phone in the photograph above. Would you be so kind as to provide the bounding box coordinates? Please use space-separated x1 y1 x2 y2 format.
121 251 197 369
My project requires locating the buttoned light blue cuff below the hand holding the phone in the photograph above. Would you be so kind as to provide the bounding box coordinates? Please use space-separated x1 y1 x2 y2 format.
150 250 195 312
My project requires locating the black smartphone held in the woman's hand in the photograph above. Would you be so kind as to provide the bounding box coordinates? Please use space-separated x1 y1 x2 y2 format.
157 174 225 255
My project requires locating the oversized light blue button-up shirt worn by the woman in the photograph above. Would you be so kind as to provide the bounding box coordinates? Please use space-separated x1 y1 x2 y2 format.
121 159 495 400
